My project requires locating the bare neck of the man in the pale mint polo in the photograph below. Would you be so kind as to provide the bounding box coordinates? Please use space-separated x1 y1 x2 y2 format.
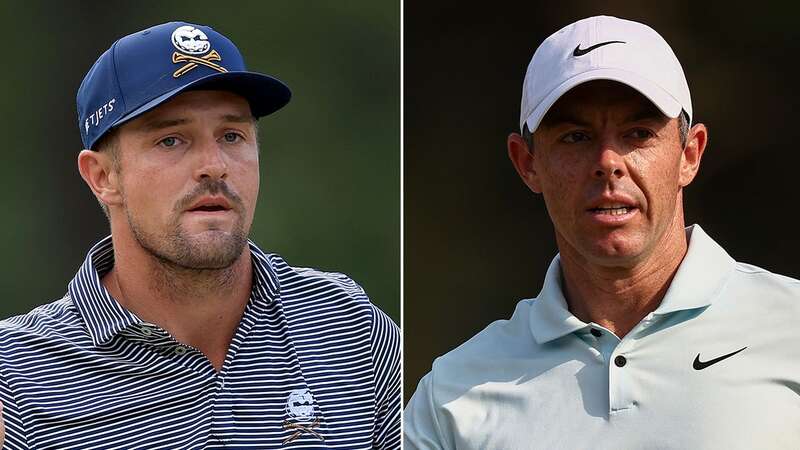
559 220 688 338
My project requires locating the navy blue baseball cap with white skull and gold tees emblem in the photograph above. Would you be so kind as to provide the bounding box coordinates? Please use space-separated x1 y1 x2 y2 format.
77 22 292 149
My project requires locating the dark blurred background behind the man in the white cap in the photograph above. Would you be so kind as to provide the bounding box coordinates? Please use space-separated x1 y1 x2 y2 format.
404 0 800 399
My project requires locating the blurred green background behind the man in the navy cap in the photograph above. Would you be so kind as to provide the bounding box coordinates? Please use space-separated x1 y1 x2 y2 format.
0 0 400 323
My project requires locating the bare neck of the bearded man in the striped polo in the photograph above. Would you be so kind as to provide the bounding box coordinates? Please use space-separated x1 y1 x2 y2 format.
102 233 253 370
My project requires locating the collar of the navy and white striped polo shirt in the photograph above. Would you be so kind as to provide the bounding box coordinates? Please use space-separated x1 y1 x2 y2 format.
68 236 280 346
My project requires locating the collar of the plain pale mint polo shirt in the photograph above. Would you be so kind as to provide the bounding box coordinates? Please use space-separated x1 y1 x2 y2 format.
530 225 735 344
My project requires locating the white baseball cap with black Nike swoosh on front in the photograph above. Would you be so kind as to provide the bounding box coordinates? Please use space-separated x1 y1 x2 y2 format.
519 16 692 133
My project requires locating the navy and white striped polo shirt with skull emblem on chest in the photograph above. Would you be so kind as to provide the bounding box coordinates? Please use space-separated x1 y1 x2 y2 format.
0 237 401 450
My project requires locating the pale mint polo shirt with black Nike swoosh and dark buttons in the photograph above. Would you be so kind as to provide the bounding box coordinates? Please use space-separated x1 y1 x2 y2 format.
404 225 800 450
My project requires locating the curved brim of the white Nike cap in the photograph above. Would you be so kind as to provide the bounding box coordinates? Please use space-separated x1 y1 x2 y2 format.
520 69 683 133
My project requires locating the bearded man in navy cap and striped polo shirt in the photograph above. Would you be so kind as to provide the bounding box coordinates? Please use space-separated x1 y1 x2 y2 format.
0 22 400 449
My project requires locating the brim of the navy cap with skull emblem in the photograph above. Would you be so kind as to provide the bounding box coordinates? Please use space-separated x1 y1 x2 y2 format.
112 72 292 127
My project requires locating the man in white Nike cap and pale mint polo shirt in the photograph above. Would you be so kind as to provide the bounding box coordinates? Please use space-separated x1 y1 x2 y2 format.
404 17 800 450
